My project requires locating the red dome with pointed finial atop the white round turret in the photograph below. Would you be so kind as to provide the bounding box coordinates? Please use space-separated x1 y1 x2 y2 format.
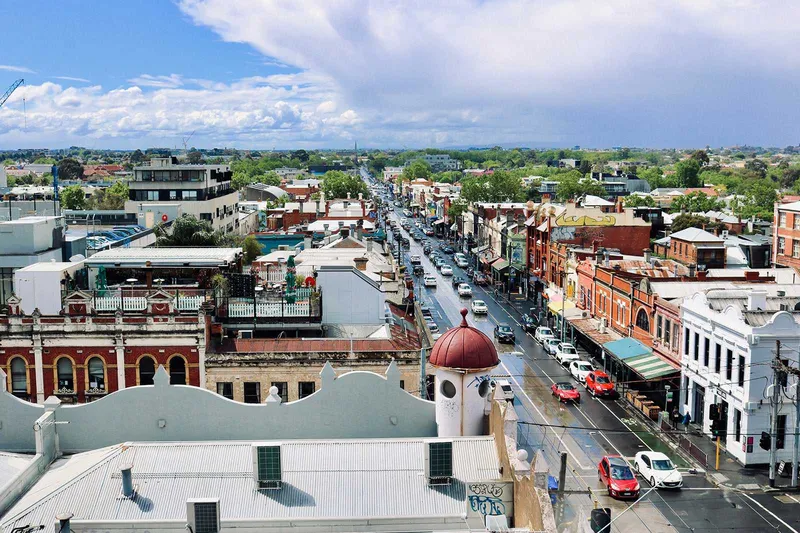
428 309 500 370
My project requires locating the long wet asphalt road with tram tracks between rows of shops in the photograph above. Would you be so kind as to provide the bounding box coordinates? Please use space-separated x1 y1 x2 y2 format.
376 185 800 533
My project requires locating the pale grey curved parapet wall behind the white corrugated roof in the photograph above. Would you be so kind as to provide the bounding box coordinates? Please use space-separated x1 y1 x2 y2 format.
0 362 436 452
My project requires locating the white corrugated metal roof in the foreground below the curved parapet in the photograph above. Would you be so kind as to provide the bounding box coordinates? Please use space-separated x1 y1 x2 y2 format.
0 437 500 533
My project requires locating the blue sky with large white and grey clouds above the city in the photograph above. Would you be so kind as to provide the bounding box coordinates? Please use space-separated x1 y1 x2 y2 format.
0 0 800 149
